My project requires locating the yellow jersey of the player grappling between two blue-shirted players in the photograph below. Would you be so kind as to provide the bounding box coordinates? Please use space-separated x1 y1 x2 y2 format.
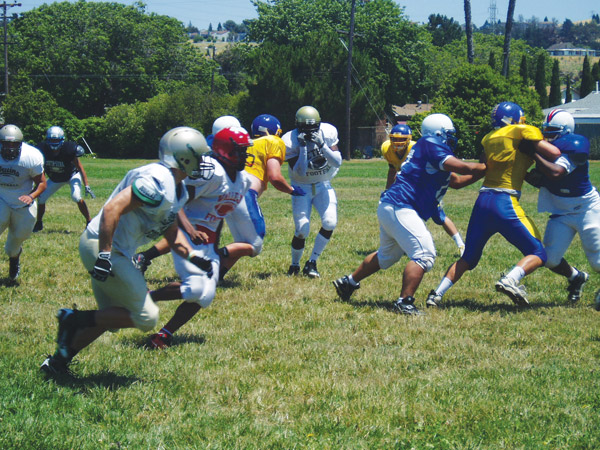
481 125 543 191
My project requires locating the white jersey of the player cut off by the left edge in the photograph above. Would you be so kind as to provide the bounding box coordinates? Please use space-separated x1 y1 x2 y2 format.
0 142 44 208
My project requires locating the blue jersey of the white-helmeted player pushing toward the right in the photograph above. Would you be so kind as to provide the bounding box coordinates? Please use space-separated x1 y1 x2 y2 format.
381 136 454 220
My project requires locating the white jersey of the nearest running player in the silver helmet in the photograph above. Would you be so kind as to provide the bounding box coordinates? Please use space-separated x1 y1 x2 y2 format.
88 163 188 257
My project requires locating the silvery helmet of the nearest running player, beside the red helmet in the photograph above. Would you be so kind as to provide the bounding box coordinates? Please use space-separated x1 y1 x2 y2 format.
158 127 215 180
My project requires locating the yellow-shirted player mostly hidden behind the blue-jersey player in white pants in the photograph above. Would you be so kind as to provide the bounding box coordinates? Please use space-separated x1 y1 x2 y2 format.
381 124 465 256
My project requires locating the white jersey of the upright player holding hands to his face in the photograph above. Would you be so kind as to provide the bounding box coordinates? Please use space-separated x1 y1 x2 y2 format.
282 123 339 184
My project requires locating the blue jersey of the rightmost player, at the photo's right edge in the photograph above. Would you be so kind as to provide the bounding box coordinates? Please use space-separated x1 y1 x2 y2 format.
543 133 593 197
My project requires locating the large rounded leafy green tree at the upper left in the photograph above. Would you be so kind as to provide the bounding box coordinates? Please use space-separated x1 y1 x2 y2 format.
10 1 216 117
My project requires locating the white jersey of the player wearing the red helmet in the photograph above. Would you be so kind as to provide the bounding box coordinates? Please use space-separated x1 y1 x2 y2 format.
184 158 251 231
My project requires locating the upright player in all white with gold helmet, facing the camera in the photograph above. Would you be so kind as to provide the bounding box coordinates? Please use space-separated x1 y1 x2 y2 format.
283 106 342 278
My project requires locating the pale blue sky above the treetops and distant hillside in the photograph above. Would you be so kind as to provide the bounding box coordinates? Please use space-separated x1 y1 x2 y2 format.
16 0 600 28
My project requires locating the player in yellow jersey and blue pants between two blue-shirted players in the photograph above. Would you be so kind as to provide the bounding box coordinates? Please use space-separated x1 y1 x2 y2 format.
426 102 560 307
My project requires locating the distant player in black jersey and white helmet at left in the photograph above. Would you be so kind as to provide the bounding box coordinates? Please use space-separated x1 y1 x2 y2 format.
33 126 96 233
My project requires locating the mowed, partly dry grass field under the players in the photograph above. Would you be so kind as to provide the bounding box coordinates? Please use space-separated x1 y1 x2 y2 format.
0 159 600 449
